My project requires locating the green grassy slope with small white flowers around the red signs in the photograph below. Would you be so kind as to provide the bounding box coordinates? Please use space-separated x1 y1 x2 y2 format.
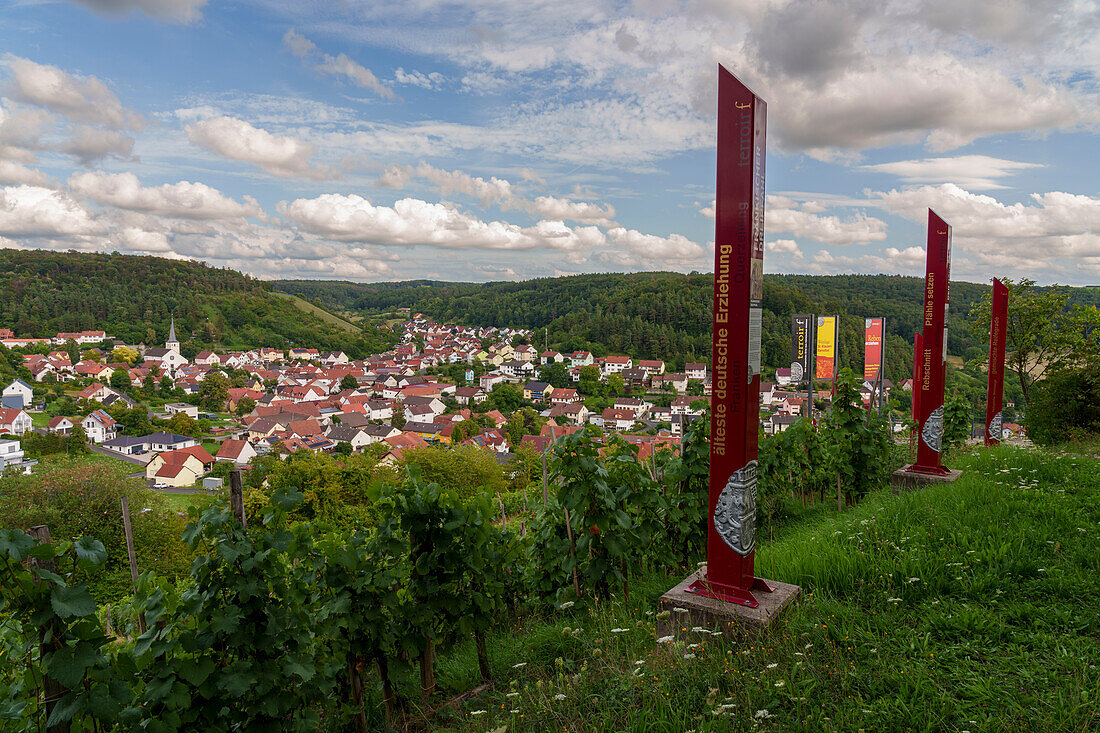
408 447 1100 733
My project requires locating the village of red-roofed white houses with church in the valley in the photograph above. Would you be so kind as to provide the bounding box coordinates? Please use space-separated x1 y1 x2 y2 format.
0 309 911 490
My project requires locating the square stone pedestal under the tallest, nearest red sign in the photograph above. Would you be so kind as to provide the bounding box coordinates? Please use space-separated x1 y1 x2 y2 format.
657 572 802 636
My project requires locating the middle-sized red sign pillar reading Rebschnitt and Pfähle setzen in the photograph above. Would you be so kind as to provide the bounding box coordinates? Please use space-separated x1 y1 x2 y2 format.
909 209 952 475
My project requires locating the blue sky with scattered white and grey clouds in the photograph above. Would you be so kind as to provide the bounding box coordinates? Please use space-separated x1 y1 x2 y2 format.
0 0 1100 285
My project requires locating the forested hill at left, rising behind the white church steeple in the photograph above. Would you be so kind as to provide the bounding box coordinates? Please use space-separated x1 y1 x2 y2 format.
0 249 393 357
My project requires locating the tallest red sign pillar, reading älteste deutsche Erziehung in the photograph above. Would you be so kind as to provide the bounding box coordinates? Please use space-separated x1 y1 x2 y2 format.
691 66 771 608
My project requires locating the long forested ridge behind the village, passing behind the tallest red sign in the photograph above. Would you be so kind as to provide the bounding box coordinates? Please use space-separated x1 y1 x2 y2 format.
276 272 1073 380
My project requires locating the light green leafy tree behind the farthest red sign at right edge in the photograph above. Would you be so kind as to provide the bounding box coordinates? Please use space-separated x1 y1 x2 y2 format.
970 277 1100 403
